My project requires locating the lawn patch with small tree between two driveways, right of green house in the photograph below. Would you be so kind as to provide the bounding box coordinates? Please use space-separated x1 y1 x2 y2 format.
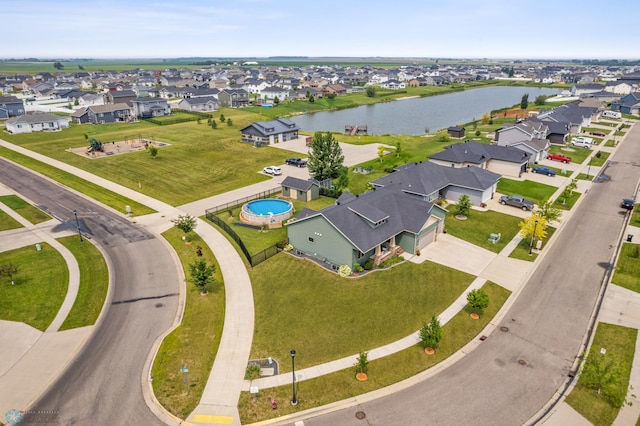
445 205 522 253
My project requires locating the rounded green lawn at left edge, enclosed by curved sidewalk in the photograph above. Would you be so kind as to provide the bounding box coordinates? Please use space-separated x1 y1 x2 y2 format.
0 243 69 331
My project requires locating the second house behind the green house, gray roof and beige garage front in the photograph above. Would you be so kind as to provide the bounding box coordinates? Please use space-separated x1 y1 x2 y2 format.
429 141 530 177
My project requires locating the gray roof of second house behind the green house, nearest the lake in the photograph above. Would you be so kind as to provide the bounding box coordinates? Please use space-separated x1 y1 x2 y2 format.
429 141 529 164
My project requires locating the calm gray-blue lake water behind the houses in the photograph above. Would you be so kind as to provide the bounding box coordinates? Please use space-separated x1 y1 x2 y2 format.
291 86 560 135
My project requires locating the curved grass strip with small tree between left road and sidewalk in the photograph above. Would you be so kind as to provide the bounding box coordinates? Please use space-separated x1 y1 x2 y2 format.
151 228 225 419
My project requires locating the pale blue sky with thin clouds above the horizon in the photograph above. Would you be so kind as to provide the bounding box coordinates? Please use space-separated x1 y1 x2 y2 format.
5 0 640 59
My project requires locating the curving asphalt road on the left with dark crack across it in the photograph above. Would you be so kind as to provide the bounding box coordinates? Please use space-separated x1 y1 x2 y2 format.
0 159 180 425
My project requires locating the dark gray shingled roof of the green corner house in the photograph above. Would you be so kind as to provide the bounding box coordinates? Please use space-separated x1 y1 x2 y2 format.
289 188 433 253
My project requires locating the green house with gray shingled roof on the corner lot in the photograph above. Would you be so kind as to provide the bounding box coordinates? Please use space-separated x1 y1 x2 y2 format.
287 187 446 269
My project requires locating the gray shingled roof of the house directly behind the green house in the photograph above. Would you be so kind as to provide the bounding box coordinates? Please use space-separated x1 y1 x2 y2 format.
371 162 501 196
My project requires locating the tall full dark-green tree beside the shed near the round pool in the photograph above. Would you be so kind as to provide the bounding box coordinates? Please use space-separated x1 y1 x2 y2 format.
307 132 344 180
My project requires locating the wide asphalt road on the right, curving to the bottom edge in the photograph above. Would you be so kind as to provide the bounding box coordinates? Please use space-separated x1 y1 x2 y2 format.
296 126 640 426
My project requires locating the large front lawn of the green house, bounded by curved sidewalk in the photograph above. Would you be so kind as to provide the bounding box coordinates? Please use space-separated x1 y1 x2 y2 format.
249 253 474 371
